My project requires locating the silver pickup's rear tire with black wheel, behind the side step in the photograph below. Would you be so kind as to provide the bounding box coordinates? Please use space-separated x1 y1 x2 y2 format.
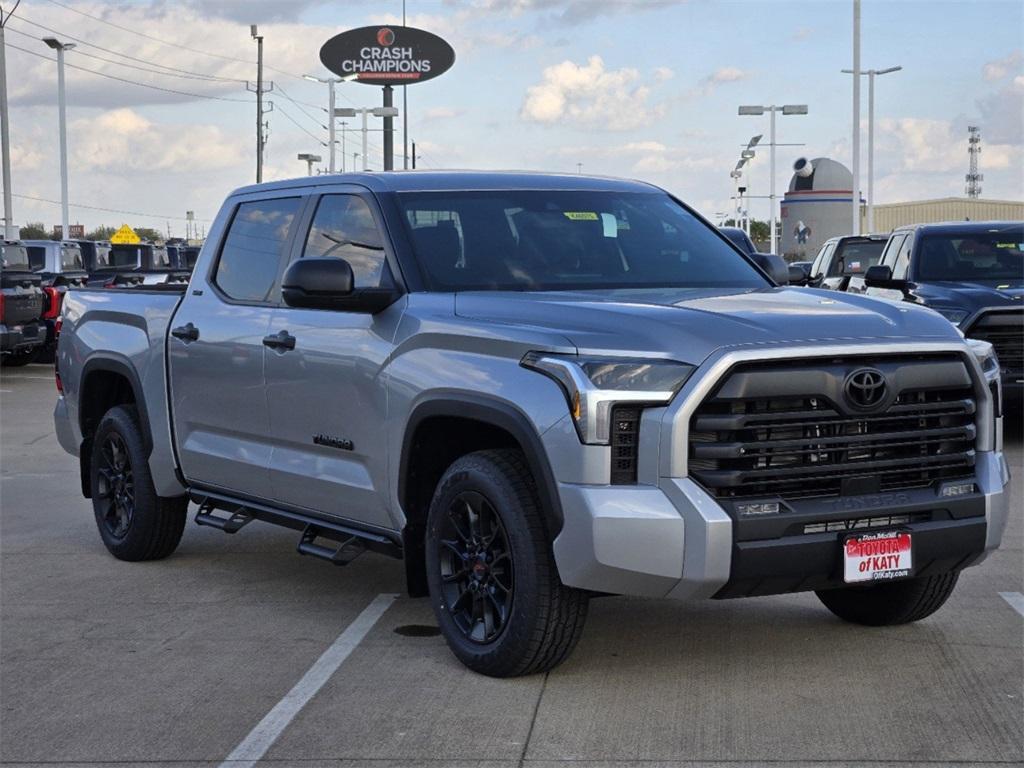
89 406 188 562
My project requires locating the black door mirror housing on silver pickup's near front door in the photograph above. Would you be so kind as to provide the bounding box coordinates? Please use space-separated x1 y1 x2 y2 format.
281 256 399 314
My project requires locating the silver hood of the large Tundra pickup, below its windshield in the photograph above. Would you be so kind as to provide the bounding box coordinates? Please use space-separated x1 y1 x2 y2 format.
456 288 961 364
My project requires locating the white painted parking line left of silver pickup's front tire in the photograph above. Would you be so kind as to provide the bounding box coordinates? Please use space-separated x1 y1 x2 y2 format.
220 594 398 768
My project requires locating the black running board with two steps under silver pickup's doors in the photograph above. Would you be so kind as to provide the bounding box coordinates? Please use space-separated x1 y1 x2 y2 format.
188 488 402 565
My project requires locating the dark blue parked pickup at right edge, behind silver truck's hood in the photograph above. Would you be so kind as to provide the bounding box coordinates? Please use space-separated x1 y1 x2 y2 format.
849 221 1024 393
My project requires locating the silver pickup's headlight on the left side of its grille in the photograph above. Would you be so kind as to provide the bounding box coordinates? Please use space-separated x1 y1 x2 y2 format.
521 352 694 445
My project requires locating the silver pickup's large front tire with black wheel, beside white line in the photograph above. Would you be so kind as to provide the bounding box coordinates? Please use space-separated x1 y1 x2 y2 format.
426 450 588 677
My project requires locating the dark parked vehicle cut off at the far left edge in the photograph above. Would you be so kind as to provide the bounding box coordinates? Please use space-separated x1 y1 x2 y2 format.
0 240 46 366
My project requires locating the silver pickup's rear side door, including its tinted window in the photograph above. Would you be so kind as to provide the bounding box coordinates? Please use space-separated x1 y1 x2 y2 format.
167 197 304 499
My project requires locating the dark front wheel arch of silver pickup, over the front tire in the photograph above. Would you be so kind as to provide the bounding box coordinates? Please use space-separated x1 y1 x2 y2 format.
397 393 563 597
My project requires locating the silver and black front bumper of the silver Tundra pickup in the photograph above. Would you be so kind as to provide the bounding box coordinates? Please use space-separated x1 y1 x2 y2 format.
554 452 1010 598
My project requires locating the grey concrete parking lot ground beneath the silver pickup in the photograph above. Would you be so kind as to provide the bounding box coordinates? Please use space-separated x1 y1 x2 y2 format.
0 366 1024 768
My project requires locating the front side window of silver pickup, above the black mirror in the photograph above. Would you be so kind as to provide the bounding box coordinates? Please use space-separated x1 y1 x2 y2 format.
302 195 391 289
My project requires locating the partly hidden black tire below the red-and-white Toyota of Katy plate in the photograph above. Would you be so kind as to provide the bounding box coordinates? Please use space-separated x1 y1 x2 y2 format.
815 571 959 627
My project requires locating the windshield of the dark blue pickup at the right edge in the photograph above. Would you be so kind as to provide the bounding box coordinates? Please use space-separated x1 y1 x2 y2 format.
914 234 1024 283
